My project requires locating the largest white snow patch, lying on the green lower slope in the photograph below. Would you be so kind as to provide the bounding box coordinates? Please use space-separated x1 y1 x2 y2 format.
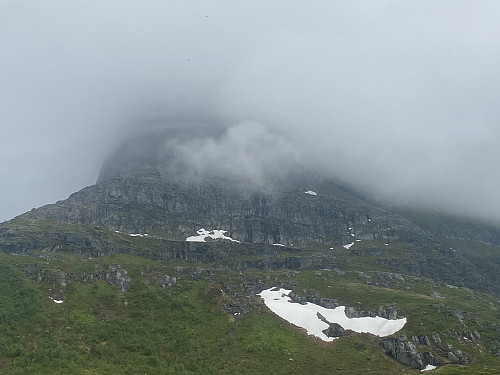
258 288 406 341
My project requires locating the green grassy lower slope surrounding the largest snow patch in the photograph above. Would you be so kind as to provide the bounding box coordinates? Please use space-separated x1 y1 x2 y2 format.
0 252 500 374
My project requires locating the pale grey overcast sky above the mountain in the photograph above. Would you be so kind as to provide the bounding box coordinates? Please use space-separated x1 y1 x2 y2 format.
0 0 500 221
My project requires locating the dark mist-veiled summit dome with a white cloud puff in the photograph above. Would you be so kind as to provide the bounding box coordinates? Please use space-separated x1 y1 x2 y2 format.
97 121 304 185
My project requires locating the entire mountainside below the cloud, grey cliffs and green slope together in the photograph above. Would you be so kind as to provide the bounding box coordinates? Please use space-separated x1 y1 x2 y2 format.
0 167 500 374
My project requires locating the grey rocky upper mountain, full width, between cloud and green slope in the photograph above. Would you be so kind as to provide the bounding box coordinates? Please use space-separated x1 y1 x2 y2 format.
0 167 500 293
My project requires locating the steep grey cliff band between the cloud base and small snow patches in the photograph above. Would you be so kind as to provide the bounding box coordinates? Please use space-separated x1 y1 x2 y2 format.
21 168 431 246
